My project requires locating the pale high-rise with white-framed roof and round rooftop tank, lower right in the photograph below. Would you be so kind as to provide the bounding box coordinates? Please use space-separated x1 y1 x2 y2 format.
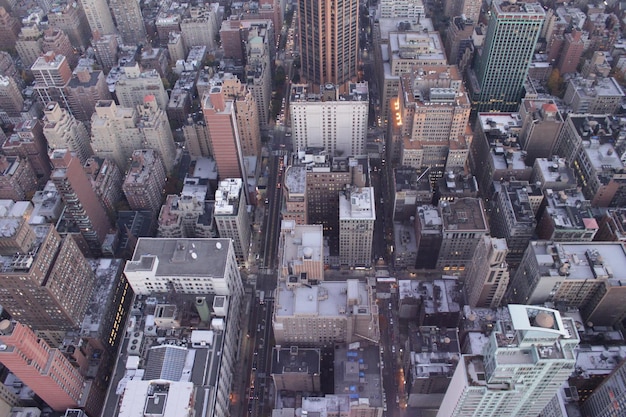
437 304 580 417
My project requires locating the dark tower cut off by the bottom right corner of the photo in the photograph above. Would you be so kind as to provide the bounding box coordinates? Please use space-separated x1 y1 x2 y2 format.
581 361 626 417
